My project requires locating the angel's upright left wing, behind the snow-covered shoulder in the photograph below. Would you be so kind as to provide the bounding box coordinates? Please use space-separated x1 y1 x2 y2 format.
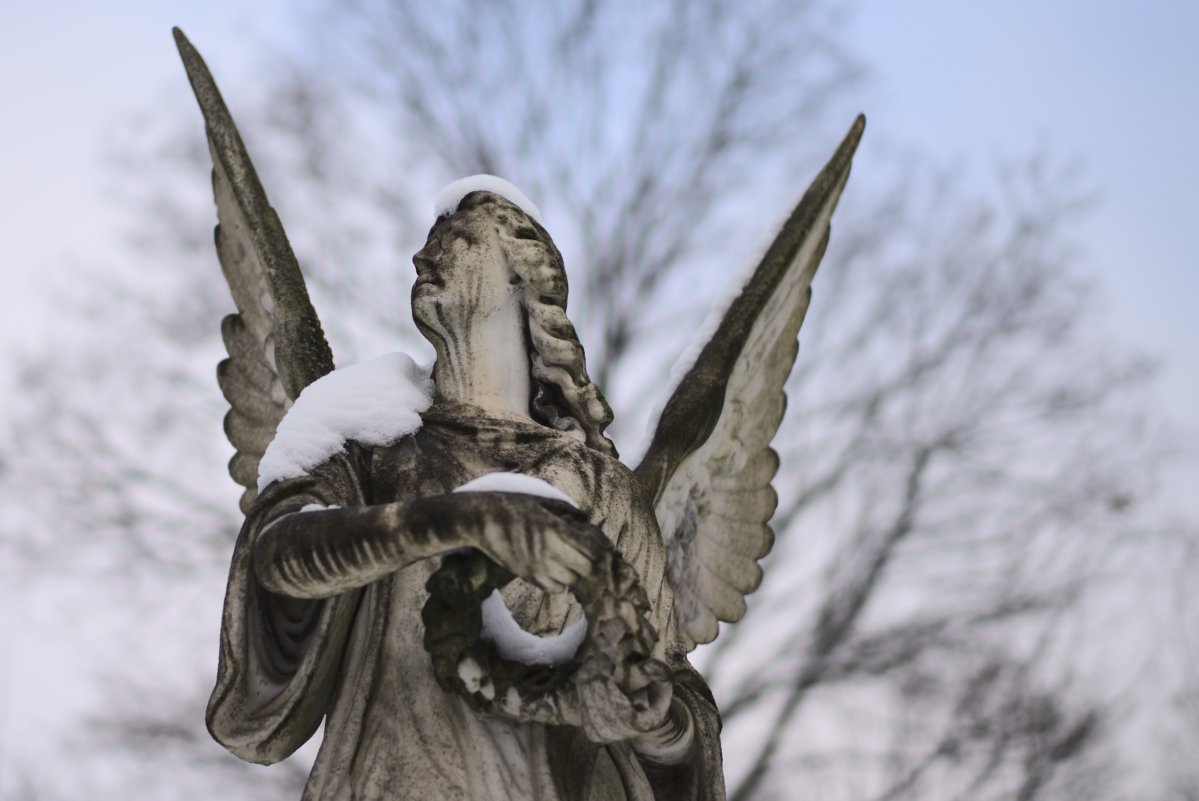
174 28 333 512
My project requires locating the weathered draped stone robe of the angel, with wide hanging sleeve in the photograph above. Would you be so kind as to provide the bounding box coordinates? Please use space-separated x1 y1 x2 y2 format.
207 409 724 801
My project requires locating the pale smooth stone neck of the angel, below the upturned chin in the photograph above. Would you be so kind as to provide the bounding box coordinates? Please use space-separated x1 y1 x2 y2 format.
433 296 531 418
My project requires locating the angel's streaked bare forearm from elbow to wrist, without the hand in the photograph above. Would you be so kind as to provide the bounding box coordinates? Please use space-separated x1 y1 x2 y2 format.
254 498 474 598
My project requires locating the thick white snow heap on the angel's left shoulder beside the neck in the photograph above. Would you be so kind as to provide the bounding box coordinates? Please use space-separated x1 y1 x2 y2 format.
258 353 433 492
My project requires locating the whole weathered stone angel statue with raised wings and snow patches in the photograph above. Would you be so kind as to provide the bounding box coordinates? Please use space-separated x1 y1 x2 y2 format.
175 29 864 801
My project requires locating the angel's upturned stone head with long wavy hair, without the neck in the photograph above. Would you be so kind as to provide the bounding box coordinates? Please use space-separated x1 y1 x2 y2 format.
412 191 616 456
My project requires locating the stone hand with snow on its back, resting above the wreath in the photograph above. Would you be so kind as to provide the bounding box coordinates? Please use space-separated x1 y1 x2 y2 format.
458 493 611 592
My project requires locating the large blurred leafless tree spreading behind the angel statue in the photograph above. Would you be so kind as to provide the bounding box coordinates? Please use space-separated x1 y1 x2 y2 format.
0 0 1155 801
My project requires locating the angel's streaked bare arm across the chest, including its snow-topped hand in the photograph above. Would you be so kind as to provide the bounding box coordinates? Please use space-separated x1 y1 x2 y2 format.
253 493 602 598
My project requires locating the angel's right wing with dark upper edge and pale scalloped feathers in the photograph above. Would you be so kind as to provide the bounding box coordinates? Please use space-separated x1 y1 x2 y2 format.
635 116 866 648
